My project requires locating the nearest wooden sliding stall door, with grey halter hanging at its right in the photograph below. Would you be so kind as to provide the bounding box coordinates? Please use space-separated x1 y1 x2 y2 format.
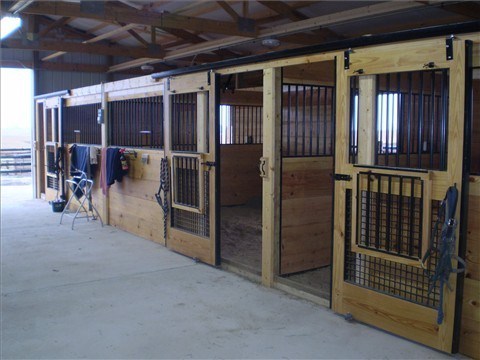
332 39 465 352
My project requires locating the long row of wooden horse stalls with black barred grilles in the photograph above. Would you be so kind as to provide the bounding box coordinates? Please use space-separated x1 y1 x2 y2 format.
31 28 480 356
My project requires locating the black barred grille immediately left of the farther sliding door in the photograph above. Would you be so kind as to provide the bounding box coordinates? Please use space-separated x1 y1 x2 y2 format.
108 96 163 149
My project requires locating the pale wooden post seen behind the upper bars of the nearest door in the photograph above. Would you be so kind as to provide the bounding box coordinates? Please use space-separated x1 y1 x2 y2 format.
358 75 377 165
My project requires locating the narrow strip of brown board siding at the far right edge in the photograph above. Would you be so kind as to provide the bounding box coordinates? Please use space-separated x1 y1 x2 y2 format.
460 176 480 359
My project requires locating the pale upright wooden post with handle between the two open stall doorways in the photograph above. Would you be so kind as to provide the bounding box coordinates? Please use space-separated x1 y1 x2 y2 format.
262 68 282 287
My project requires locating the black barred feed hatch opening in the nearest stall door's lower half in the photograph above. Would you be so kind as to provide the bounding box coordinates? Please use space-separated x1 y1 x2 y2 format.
356 172 423 259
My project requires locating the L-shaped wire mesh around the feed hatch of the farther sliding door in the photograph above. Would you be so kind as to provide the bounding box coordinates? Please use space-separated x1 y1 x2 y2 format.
172 171 210 238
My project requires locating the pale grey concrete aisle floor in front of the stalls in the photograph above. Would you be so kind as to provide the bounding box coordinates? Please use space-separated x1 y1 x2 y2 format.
1 184 448 359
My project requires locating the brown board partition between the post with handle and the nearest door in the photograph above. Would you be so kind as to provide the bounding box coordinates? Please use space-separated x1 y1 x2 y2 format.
280 157 333 274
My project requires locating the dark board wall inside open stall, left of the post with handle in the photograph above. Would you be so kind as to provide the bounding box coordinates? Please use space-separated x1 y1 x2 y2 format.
220 145 263 206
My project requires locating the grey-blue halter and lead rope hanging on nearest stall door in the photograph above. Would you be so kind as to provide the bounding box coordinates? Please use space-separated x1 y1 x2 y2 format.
422 186 465 325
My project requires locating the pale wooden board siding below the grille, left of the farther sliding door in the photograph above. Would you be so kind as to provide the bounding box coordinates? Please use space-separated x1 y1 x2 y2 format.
108 150 165 245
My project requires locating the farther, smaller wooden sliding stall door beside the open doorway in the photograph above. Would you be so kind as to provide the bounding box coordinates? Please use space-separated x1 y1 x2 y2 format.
164 72 219 265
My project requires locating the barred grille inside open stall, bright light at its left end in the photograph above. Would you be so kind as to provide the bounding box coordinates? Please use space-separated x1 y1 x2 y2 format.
220 105 263 144
